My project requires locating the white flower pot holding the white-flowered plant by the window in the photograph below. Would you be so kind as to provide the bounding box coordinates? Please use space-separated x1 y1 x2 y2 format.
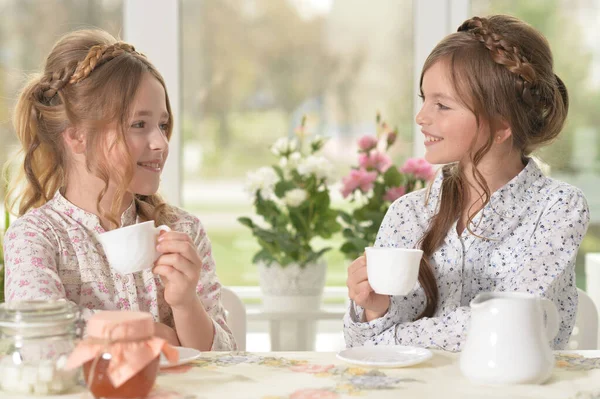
258 261 327 351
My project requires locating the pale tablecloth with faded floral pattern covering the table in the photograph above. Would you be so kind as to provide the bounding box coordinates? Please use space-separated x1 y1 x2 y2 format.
5 351 600 399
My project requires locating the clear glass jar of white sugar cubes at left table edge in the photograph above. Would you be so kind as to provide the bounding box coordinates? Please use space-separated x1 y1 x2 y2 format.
0 300 82 395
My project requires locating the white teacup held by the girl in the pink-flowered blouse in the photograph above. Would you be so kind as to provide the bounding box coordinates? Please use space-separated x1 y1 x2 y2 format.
97 220 171 274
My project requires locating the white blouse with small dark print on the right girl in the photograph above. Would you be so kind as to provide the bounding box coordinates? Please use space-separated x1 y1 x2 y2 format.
344 160 590 351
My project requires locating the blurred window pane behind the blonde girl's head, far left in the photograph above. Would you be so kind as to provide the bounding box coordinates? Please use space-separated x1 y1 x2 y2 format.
0 0 122 189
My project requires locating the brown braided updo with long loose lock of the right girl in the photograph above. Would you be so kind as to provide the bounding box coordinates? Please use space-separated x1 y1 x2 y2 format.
412 15 569 318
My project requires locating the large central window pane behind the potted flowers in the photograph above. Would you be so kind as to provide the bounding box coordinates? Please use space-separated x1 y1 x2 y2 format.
181 0 413 285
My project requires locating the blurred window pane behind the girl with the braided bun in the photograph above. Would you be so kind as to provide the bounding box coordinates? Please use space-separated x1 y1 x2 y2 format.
471 0 600 287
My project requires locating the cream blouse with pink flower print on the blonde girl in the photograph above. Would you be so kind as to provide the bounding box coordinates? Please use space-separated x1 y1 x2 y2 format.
4 192 236 351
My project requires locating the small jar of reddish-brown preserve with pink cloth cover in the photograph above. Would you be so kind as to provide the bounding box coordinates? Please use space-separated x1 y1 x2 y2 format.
66 311 178 399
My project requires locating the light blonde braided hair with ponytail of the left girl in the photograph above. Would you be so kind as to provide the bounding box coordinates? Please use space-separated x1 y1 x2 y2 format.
6 30 173 227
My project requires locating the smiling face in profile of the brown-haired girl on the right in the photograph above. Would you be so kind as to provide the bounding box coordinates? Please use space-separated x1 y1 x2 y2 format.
415 61 487 164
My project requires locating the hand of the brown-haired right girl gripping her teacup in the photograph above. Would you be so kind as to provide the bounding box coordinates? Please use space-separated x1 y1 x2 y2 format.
346 255 390 321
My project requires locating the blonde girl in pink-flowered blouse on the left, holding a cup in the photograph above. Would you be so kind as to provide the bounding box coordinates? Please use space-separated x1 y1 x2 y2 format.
4 30 235 350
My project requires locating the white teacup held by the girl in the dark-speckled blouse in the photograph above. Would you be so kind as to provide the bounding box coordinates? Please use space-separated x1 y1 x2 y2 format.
365 247 423 295
